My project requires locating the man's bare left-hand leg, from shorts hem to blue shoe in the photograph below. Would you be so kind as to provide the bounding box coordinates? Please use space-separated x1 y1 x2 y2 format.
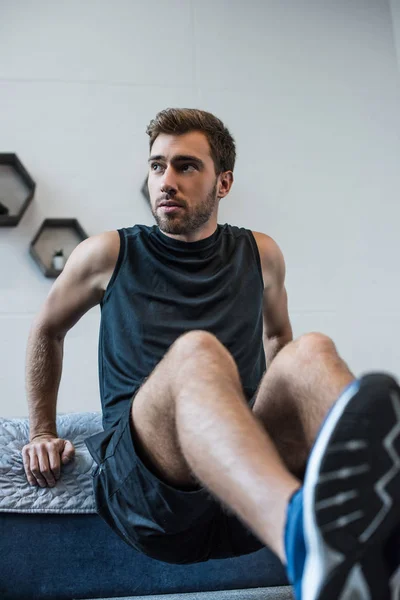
132 331 300 560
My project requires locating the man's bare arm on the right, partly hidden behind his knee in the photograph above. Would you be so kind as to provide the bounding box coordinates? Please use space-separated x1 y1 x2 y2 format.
253 232 293 368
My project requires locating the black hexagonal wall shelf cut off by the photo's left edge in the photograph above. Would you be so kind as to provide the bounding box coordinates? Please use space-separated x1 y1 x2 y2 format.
0 153 36 227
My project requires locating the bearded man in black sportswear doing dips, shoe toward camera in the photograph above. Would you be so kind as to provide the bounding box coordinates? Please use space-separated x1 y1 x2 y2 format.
23 109 400 600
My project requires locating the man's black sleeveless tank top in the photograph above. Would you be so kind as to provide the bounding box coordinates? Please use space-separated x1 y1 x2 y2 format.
99 225 265 430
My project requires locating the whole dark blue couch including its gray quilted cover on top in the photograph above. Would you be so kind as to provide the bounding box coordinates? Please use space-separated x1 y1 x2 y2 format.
0 413 291 600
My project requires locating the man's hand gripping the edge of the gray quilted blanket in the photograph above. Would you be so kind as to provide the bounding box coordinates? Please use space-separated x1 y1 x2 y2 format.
22 434 75 487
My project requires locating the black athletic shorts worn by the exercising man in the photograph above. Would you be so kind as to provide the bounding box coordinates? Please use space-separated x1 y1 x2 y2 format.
85 398 264 564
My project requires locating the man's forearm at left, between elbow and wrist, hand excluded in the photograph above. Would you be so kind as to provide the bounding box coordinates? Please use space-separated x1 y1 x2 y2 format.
26 326 63 441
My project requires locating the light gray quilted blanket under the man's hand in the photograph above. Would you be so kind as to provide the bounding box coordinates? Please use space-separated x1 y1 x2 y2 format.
0 412 102 513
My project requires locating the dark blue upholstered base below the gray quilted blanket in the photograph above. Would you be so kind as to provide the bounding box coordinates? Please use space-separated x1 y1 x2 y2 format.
0 513 291 600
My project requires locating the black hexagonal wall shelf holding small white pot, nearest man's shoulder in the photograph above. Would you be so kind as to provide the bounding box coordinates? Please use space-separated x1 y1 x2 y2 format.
29 219 88 279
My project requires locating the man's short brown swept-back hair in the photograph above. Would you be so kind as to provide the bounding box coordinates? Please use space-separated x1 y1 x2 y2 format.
146 108 236 175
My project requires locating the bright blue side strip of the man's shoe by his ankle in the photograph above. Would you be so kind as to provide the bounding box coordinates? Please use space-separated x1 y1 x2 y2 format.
285 488 306 600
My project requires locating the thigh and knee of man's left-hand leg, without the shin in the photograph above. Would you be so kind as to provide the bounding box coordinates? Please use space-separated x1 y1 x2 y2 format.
131 331 236 490
